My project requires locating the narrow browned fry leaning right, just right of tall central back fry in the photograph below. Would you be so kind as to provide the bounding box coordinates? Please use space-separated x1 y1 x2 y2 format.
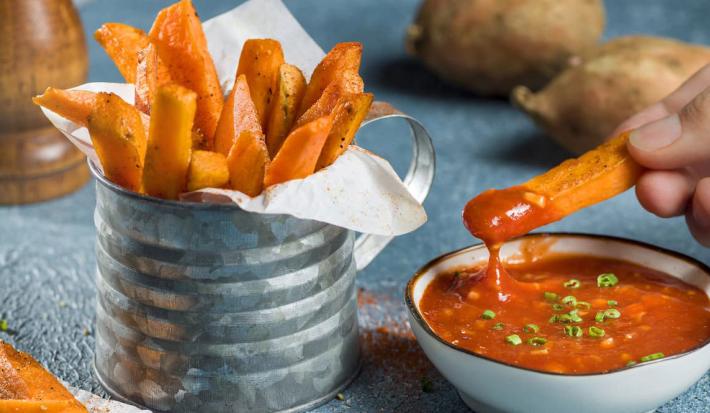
266 63 306 158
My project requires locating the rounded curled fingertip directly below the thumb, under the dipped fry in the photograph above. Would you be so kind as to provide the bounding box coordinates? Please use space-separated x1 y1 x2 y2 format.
636 171 693 218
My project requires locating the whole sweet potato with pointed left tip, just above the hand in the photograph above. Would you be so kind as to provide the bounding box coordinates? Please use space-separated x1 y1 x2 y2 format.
512 36 710 153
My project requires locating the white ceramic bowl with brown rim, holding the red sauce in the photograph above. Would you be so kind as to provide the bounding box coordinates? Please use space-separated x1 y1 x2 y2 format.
405 234 710 413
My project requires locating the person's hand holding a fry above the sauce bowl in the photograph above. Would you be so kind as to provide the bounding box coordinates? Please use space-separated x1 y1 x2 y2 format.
617 65 710 246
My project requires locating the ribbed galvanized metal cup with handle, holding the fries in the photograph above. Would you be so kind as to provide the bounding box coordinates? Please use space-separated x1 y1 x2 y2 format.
91 103 434 412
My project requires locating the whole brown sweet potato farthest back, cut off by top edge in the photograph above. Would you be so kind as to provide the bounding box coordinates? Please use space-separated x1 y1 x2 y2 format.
407 0 604 96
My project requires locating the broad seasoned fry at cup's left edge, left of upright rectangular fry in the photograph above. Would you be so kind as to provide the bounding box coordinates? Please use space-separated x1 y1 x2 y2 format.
88 93 146 192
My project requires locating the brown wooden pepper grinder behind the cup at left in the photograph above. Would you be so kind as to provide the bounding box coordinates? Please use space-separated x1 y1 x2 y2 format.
0 0 89 204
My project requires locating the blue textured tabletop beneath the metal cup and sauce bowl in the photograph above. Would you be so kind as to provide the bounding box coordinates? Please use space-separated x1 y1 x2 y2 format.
0 0 710 413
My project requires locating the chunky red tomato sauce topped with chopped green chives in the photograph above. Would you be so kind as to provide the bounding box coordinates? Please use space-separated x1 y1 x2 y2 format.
420 255 710 374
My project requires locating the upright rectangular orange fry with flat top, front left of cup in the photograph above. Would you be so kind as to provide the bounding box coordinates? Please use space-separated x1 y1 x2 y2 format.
143 83 197 199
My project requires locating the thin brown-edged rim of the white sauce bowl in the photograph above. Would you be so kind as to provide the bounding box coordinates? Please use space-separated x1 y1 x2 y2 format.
404 231 710 377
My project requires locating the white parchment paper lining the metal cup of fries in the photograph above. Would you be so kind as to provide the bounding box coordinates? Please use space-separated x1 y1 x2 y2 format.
42 0 427 235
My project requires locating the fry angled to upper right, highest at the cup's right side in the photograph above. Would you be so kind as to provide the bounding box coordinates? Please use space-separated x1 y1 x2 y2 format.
298 42 362 116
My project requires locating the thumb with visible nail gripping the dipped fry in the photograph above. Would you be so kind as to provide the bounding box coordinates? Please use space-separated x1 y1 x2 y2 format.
628 88 710 169
